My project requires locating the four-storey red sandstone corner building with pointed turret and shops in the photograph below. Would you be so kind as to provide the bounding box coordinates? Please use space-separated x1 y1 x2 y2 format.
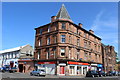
34 5 102 75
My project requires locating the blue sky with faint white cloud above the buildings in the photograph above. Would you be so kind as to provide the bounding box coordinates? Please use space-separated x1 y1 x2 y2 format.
2 2 118 57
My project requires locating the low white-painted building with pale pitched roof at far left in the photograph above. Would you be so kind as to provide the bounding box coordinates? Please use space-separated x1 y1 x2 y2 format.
0 45 34 67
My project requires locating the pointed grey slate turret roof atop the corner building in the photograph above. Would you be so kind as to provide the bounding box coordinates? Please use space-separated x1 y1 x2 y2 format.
56 4 70 20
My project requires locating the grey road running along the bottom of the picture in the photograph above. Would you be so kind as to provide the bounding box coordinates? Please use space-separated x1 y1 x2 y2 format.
0 72 120 80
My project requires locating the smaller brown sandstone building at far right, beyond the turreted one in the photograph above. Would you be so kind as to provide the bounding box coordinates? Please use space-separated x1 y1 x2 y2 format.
102 44 117 72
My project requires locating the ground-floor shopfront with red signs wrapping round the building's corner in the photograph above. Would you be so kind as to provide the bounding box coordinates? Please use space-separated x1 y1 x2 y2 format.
35 60 98 76
